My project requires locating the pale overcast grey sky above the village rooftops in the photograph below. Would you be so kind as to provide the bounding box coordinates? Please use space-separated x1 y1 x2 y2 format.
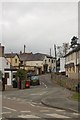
0 2 78 54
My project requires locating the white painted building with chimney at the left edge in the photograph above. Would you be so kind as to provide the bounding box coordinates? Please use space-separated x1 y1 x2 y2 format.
0 44 16 85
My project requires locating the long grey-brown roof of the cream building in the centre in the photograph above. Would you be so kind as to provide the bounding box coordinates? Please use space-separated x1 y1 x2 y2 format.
19 53 53 61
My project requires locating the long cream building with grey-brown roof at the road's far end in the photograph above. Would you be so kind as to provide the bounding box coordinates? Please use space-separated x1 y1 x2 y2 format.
19 53 55 74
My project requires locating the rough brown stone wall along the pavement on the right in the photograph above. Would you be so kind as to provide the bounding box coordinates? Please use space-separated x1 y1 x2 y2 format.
51 73 78 91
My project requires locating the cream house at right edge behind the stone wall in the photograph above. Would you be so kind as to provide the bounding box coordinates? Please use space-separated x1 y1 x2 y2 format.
65 45 80 80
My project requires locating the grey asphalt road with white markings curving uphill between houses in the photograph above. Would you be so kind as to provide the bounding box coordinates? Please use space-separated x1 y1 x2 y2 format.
1 76 78 120
